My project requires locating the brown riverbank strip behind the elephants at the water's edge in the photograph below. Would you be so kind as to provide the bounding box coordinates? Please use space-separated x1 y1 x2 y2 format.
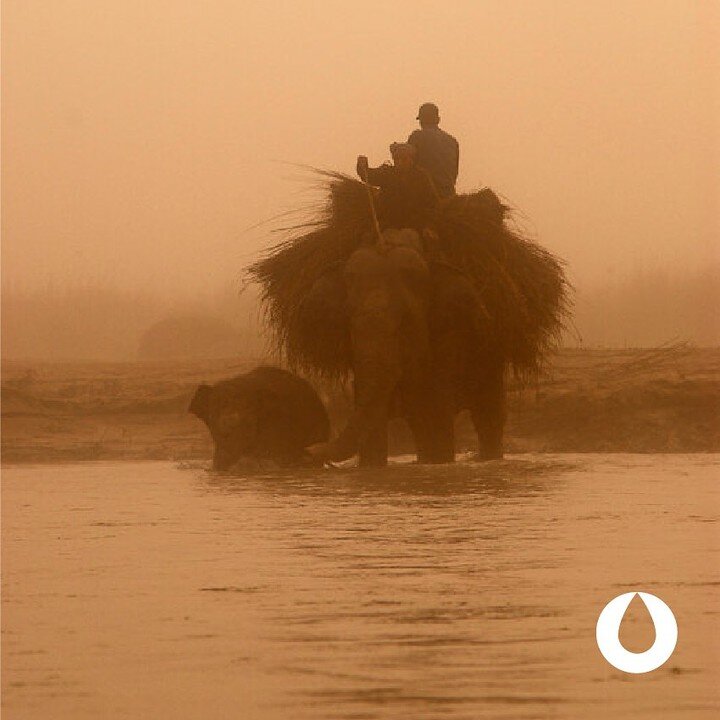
2 345 720 463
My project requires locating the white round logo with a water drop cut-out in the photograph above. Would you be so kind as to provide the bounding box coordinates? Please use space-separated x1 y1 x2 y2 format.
595 592 677 673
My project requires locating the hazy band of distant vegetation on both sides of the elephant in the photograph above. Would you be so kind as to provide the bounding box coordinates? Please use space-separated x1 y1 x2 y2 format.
2 268 720 360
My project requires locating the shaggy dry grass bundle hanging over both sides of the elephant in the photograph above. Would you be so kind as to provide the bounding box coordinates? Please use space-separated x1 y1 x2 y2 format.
248 172 569 378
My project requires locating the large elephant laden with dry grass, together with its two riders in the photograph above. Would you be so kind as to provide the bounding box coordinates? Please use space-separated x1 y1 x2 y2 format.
245 125 568 466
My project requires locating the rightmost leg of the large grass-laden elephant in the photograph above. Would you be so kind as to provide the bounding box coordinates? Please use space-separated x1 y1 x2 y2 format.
471 358 505 460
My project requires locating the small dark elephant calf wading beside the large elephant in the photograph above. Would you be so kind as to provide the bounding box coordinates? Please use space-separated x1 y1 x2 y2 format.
189 366 330 470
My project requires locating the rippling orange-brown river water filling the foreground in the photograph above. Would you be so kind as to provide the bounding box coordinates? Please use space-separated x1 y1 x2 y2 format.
2 455 720 720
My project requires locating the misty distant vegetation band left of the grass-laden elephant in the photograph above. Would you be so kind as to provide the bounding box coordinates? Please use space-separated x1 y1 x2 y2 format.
2 284 264 360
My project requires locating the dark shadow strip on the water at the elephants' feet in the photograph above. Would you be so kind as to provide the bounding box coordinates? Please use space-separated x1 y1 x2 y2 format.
194 456 578 497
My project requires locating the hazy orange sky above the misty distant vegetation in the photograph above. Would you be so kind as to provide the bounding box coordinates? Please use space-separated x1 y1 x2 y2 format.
2 0 720 288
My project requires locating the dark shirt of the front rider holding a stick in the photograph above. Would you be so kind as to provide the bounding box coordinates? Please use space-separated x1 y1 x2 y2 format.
367 165 437 232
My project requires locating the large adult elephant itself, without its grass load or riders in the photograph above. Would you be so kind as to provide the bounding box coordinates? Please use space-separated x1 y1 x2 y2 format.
308 230 506 466
